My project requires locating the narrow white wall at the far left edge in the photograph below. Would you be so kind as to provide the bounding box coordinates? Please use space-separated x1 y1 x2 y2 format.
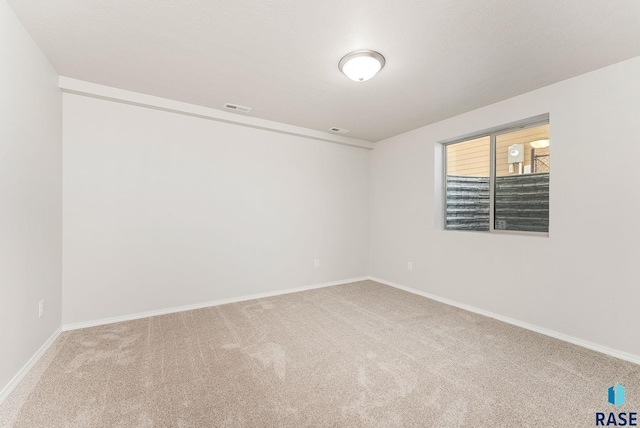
0 0 62 395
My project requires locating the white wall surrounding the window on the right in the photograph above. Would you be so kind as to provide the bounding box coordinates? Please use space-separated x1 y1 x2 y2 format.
370 58 640 356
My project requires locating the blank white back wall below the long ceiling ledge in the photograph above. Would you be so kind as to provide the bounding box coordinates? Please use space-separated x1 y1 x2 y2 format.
63 93 370 324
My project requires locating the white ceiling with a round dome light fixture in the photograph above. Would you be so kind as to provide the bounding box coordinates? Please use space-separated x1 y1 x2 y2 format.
8 0 640 141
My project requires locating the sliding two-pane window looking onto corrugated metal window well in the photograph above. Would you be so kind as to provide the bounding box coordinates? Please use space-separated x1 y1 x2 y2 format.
443 116 551 234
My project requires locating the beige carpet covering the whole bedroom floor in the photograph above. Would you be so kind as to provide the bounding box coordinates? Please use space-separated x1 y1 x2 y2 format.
0 281 640 427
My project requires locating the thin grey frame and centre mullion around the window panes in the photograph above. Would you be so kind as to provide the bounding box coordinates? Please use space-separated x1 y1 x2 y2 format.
438 113 551 237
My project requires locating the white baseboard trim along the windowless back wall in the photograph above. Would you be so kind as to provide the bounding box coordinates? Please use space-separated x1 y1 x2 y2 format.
62 276 369 331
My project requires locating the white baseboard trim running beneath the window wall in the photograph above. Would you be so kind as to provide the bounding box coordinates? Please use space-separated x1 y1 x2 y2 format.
368 276 640 364
